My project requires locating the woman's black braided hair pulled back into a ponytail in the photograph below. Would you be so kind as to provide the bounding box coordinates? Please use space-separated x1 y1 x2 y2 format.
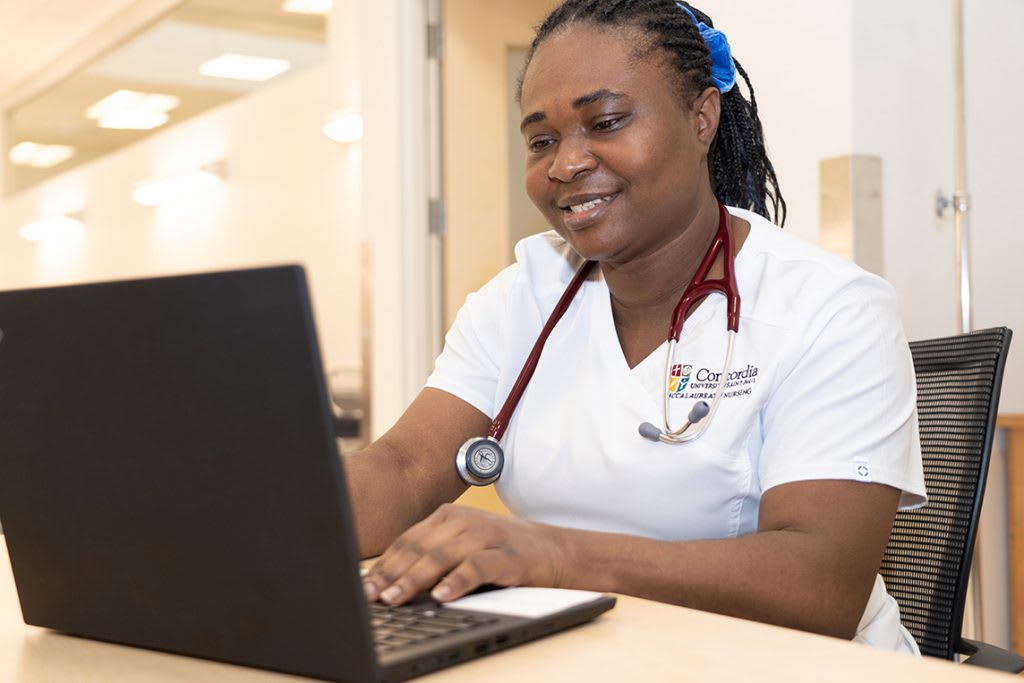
519 0 785 225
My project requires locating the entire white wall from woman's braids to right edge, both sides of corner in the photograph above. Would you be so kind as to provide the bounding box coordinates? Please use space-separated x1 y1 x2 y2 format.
697 0 1024 413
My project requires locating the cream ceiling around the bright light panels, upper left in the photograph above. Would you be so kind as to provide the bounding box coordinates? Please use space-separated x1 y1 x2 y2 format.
0 0 326 194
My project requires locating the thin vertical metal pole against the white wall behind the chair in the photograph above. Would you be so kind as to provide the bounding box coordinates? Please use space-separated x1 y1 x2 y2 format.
952 0 984 640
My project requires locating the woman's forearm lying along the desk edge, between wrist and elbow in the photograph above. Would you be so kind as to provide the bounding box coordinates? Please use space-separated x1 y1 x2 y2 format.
553 528 873 638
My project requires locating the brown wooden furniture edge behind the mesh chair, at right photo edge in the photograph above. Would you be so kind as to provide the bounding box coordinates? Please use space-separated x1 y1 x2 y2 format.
995 415 1024 652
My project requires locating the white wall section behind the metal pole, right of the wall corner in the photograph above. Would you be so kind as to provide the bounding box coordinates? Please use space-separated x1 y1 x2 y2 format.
854 0 1024 389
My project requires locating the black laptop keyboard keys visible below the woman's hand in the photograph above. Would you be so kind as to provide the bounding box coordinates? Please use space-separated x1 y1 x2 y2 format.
370 602 498 652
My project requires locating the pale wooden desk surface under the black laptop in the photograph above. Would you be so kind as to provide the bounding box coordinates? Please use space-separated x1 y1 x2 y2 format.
0 542 1010 683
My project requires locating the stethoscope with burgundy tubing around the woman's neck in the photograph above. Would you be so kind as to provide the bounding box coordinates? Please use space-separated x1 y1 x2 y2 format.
455 202 739 486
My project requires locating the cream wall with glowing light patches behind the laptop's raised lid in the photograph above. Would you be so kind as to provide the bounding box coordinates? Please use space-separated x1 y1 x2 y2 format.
0 50 360 378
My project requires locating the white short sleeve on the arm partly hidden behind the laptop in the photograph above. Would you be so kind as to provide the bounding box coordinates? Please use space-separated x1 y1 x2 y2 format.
426 265 519 419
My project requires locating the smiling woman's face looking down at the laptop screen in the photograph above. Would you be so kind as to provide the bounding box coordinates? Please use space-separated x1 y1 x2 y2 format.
520 25 719 262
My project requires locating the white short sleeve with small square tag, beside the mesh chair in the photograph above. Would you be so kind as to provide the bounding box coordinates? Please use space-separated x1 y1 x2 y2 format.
759 279 926 509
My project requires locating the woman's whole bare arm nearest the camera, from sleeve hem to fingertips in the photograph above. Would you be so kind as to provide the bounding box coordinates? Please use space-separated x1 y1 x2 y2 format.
365 480 899 638
